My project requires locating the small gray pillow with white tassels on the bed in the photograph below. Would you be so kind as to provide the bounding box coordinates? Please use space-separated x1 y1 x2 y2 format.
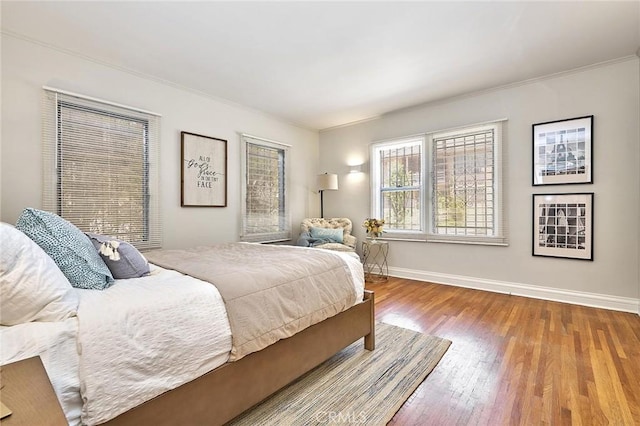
86 232 149 279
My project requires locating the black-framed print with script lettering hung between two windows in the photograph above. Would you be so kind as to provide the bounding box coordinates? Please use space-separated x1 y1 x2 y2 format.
180 132 227 207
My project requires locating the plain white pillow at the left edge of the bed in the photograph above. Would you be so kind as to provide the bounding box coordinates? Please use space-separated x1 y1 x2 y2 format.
0 222 78 325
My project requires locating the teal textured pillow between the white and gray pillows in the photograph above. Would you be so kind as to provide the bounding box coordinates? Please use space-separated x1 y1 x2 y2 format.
16 208 114 290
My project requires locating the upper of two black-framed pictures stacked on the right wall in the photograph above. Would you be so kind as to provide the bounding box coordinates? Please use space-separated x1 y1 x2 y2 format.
531 115 593 186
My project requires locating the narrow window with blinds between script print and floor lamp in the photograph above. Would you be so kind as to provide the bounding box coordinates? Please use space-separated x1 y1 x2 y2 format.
240 134 291 242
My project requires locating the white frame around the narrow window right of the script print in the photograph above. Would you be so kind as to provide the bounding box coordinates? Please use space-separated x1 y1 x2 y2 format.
239 133 292 243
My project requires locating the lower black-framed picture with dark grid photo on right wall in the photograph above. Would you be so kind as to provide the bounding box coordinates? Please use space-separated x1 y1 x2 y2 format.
532 192 593 260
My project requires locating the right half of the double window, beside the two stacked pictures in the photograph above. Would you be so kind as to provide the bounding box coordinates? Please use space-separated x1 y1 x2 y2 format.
427 123 507 244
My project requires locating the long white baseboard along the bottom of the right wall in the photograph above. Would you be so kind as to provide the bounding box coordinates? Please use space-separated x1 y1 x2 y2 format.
389 267 640 315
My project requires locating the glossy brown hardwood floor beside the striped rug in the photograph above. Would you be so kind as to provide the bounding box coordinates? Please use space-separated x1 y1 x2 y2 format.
367 278 640 426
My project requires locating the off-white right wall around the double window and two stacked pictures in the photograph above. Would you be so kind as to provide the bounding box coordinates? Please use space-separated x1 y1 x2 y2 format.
320 57 640 312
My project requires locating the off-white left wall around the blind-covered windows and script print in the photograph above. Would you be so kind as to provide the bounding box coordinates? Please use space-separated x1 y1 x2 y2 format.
0 35 319 248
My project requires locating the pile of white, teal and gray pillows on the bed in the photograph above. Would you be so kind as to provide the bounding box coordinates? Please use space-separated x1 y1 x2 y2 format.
0 208 149 325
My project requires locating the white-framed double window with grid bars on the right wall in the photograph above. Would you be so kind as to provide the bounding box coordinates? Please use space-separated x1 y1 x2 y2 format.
371 122 507 244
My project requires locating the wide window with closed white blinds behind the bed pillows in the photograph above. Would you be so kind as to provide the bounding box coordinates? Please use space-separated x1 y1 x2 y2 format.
43 88 162 249
